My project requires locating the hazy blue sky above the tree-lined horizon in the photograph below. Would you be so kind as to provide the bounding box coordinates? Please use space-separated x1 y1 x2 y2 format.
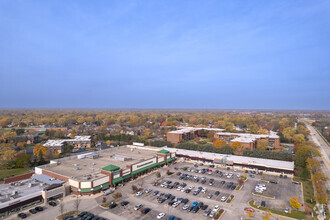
0 0 330 110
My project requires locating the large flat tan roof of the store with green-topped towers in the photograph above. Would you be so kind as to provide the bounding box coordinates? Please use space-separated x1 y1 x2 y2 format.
39 146 160 181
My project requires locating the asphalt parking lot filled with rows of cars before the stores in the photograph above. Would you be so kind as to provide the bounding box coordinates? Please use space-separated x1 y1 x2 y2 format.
99 162 301 219
